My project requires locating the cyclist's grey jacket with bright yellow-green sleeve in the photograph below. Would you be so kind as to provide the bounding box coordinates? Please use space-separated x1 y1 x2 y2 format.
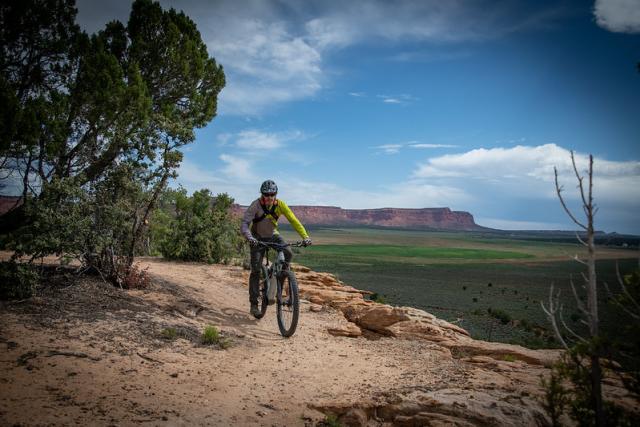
240 198 309 239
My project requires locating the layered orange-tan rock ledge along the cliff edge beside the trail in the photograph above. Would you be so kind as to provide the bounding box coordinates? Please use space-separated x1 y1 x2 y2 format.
294 266 635 426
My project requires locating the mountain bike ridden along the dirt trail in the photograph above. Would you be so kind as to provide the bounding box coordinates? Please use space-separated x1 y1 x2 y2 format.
255 241 305 337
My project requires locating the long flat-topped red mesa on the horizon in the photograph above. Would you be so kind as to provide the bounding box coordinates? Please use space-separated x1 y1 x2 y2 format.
233 205 485 231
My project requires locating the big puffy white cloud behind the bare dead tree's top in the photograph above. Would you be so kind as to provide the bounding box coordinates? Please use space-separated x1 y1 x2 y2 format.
412 144 640 231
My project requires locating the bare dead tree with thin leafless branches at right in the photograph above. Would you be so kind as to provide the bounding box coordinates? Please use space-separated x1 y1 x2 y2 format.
540 151 605 426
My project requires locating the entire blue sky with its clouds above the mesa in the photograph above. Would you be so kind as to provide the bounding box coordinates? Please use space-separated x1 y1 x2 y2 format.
78 0 640 234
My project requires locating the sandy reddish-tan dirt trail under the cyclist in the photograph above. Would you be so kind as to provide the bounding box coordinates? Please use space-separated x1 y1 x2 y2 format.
0 260 470 426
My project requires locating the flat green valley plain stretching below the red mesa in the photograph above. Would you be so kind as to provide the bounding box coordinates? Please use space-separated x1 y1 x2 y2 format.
283 228 638 347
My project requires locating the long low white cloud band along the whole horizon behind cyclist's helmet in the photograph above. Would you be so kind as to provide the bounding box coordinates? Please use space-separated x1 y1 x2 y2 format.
180 142 640 233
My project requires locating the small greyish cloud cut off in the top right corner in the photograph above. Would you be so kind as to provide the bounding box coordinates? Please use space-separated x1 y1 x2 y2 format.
593 0 640 33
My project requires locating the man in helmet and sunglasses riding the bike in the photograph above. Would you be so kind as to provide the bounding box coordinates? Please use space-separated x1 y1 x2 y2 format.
240 179 311 316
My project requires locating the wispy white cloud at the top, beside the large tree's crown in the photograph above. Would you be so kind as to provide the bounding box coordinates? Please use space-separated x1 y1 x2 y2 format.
78 0 564 116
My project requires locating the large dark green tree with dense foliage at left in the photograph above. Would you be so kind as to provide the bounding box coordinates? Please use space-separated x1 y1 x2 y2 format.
0 0 225 283
